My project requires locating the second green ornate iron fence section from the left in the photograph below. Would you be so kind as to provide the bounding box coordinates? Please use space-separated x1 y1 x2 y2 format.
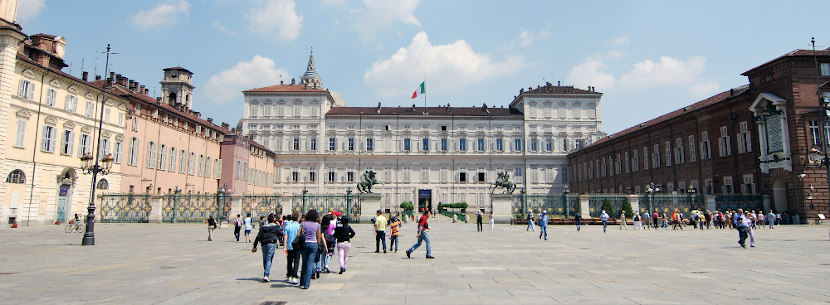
161 194 220 222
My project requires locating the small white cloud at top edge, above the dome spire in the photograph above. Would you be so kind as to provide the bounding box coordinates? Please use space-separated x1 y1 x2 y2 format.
247 0 303 41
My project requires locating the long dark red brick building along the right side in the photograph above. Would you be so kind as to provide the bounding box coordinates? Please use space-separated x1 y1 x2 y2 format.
568 49 830 220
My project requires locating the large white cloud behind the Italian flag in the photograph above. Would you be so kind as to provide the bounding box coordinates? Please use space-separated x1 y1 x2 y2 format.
363 32 525 98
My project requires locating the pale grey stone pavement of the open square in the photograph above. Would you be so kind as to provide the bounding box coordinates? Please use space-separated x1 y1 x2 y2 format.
0 216 830 304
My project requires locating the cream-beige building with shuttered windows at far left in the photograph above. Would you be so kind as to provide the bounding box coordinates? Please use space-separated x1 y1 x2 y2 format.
0 13 126 225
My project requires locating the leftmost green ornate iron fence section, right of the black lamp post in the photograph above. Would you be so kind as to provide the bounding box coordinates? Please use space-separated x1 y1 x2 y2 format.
100 194 151 222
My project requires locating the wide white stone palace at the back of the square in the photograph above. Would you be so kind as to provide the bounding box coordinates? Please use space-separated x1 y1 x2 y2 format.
240 50 603 211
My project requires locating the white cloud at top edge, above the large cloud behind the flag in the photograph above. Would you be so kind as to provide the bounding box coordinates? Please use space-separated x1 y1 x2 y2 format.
354 0 421 39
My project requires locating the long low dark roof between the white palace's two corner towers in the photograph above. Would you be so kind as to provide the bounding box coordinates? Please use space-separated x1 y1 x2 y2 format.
326 107 521 116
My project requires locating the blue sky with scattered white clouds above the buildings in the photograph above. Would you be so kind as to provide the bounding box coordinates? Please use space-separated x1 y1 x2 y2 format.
16 0 830 134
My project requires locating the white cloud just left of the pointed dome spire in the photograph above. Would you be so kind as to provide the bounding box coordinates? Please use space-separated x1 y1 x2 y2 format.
203 55 290 104
